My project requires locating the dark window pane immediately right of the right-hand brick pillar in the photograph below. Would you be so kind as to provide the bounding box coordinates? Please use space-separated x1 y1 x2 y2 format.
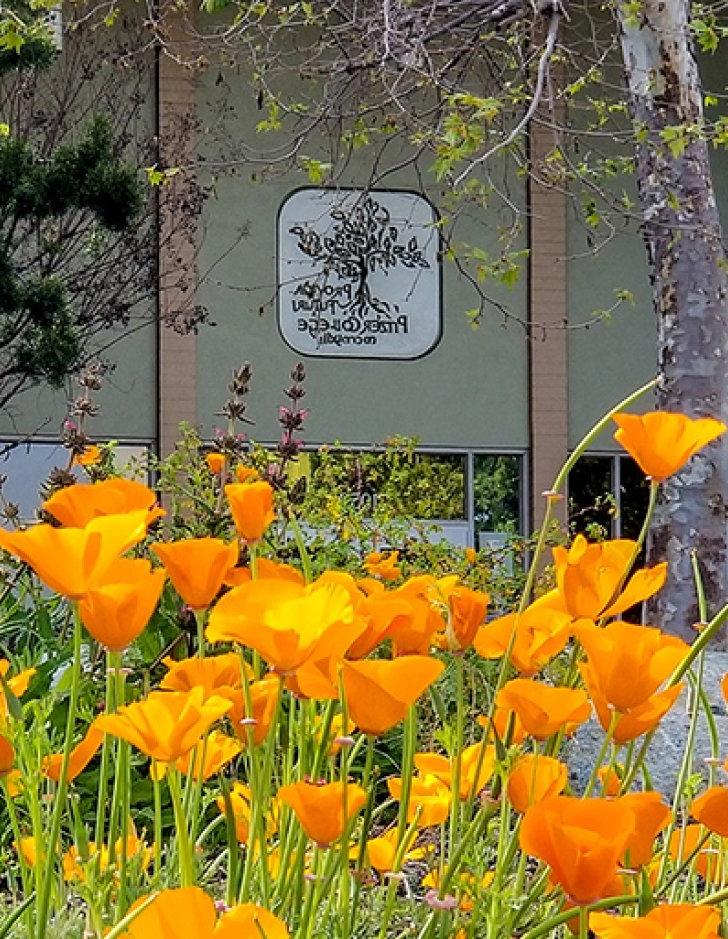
569 456 616 540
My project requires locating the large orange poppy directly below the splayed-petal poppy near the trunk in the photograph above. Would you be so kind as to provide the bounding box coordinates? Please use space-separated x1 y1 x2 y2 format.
576 621 689 743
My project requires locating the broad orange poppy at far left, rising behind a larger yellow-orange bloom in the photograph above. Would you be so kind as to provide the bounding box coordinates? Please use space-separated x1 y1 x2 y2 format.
43 477 165 528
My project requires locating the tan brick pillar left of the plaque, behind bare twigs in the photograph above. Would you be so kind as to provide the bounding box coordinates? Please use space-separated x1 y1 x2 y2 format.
158 5 197 456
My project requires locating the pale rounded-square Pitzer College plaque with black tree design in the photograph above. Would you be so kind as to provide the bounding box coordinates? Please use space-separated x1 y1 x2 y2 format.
278 188 442 359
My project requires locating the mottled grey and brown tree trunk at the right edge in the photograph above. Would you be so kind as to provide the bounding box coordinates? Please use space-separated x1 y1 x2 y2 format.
616 0 728 640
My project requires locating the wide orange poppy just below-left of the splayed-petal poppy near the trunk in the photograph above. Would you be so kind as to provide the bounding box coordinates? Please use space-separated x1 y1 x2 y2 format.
473 604 572 678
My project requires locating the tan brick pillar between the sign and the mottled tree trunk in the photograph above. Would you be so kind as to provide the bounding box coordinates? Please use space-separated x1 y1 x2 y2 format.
528 123 569 529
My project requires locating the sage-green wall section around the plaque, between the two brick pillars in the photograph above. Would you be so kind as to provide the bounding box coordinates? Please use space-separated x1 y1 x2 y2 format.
197 69 528 449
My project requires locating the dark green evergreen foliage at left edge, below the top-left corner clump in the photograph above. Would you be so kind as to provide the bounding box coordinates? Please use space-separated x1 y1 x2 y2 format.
0 118 142 387
